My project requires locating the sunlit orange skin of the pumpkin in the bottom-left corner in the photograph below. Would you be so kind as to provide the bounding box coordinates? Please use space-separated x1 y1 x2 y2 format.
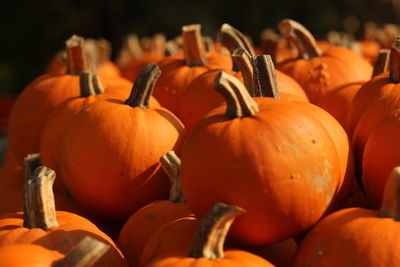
0 244 64 267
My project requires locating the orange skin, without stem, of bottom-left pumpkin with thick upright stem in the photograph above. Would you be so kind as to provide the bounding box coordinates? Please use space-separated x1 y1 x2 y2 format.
0 211 126 266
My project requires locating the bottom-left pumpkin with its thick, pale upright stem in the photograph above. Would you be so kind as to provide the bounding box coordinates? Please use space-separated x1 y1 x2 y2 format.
0 166 126 266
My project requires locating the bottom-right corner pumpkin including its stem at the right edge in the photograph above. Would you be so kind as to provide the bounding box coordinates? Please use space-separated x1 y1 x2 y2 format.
293 168 400 267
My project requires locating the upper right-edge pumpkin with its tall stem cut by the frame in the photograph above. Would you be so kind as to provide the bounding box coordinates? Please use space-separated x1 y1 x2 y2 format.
347 37 400 138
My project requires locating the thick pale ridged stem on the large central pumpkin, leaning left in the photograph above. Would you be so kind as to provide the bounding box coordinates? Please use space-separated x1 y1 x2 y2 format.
214 72 258 119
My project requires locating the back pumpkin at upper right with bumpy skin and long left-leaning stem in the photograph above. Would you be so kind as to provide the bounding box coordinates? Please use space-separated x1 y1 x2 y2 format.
277 19 372 103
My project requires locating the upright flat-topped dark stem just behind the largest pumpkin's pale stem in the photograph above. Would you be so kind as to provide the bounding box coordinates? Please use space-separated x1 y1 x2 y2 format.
252 55 279 99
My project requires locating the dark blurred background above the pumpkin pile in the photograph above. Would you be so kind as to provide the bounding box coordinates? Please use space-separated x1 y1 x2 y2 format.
0 0 400 93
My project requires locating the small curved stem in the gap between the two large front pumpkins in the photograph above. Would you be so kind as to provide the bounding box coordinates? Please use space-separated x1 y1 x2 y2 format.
160 151 186 203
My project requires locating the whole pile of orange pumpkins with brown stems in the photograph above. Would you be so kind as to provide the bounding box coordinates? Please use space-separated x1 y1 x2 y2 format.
0 19 400 267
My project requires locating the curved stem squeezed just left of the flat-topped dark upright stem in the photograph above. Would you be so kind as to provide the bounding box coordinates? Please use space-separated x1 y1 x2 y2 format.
232 47 254 96
